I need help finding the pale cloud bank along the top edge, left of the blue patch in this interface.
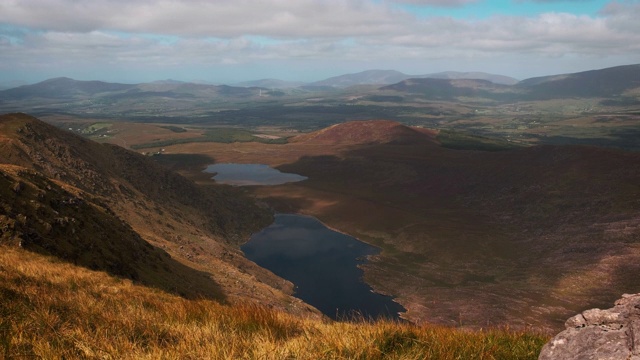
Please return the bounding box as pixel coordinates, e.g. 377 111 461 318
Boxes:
0 0 411 38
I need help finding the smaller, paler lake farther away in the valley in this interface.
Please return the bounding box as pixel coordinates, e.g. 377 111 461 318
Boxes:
204 164 307 186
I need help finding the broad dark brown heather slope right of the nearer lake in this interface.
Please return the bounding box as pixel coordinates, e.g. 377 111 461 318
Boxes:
274 131 640 328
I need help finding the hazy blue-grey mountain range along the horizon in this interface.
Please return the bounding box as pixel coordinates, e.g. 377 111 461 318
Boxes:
0 65 640 108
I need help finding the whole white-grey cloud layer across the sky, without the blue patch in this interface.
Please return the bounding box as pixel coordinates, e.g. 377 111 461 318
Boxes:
0 0 640 81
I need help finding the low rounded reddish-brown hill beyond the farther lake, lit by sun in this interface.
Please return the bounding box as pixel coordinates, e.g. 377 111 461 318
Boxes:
290 120 436 145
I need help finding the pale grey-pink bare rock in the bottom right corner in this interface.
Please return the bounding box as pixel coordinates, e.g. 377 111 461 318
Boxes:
538 294 640 360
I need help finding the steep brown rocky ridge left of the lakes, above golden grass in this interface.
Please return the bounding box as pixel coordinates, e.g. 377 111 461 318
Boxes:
0 114 304 308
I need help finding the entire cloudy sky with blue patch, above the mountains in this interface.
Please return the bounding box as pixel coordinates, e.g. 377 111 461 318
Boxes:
0 0 640 84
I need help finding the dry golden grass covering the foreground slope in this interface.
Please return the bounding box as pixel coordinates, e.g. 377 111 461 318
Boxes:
0 246 547 359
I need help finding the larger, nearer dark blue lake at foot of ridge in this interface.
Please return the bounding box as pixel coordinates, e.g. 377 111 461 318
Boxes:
242 214 406 319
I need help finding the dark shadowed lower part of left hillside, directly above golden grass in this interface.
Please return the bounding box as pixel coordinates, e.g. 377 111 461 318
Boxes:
0 171 225 302
